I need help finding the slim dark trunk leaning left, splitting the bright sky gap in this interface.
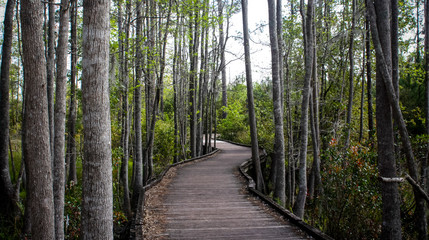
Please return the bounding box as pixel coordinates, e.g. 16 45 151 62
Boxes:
241 0 265 191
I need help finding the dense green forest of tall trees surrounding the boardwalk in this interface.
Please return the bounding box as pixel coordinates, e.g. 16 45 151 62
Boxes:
0 0 429 239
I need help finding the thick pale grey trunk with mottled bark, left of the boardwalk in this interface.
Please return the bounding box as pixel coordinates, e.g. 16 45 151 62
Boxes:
82 0 113 239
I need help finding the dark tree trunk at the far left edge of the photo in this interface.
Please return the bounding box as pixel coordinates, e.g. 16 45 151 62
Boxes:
0 0 17 219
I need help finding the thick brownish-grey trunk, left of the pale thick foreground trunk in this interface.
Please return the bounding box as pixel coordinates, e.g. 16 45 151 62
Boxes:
21 0 55 236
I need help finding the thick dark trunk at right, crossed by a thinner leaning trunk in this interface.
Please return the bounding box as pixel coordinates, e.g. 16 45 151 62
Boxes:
368 0 402 239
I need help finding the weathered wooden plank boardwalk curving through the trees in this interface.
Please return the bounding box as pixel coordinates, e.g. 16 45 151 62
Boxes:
164 142 308 240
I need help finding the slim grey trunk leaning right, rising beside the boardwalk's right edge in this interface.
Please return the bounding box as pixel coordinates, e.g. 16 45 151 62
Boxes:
293 0 314 218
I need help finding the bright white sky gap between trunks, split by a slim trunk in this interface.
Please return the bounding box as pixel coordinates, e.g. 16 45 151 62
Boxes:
225 0 271 82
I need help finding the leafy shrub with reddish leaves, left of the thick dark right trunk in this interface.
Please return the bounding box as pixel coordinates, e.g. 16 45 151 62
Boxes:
307 139 381 239
